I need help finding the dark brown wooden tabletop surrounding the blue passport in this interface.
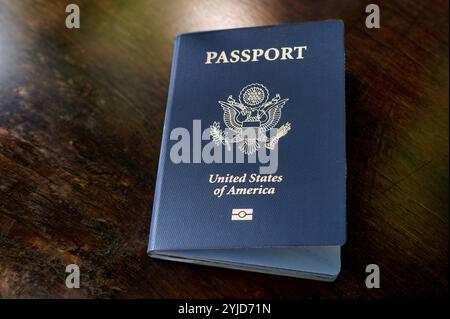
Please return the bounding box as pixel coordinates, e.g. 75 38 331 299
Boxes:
0 0 449 298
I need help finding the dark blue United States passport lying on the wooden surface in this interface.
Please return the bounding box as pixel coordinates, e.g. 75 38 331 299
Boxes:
148 20 346 281
